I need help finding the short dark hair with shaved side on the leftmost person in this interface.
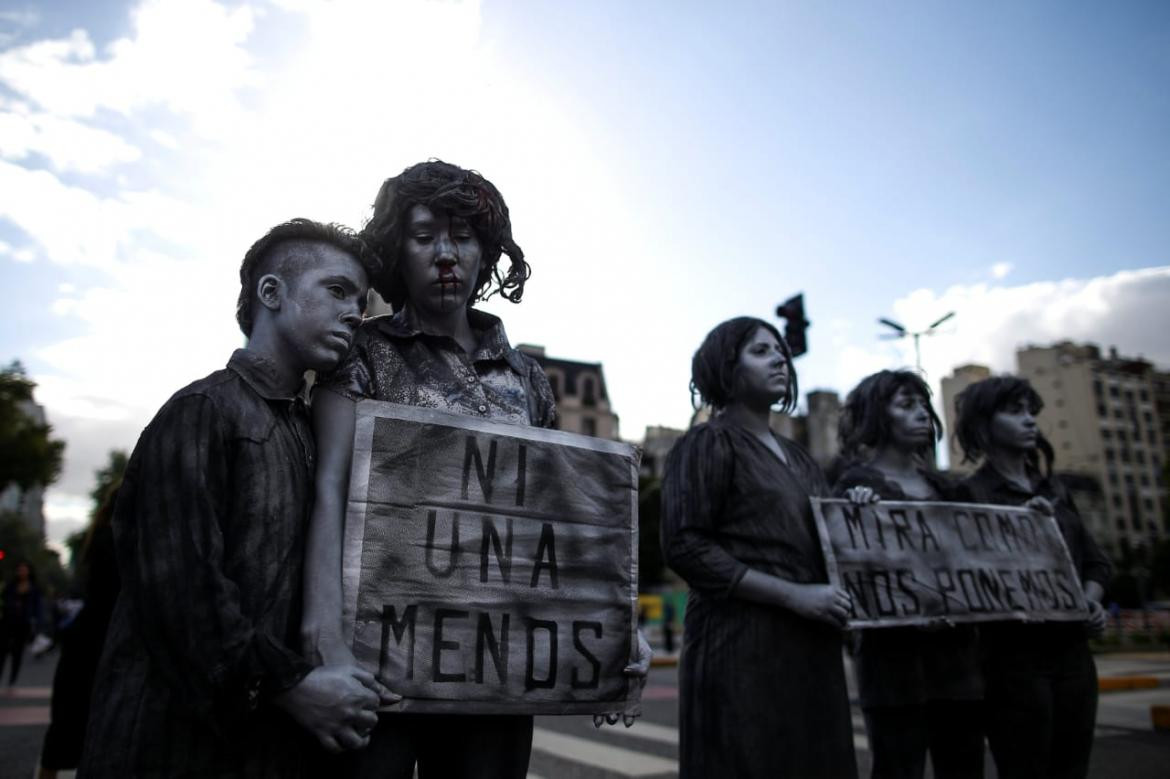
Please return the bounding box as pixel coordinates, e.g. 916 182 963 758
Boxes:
235 219 379 336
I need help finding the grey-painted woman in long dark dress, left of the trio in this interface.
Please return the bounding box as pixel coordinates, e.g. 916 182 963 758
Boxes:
662 317 856 779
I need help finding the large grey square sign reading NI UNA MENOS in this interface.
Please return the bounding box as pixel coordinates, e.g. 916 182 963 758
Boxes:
343 400 639 713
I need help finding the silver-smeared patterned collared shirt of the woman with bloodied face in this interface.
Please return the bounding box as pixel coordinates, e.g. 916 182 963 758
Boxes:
317 306 556 427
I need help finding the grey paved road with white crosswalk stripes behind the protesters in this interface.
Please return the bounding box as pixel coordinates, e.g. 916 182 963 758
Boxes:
0 653 1170 779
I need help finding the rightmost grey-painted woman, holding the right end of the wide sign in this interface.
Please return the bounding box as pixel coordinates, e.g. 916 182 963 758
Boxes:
955 377 1110 779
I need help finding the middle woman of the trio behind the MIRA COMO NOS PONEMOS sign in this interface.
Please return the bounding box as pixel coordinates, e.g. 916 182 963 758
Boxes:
834 371 983 779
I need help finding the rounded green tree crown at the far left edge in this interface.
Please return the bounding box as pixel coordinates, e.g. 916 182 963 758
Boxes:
0 363 66 489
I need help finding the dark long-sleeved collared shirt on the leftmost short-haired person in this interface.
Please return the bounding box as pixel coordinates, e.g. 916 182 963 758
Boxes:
82 350 315 777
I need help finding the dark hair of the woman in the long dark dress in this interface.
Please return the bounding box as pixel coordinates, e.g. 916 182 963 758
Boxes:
690 317 799 414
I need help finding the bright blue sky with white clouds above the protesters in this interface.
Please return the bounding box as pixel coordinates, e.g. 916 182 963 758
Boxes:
0 0 1170 538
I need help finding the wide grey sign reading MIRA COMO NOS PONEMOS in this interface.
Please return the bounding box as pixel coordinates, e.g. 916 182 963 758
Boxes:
812 498 1088 627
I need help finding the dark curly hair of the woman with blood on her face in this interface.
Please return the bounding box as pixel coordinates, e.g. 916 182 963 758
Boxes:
362 159 532 310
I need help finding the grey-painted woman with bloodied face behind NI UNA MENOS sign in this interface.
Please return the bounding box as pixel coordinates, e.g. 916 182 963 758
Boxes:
304 160 556 779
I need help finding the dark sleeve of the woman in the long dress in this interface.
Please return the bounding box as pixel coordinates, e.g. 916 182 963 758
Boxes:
661 426 748 595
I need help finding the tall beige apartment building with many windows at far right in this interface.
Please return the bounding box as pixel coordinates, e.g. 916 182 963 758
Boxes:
1016 342 1170 551
